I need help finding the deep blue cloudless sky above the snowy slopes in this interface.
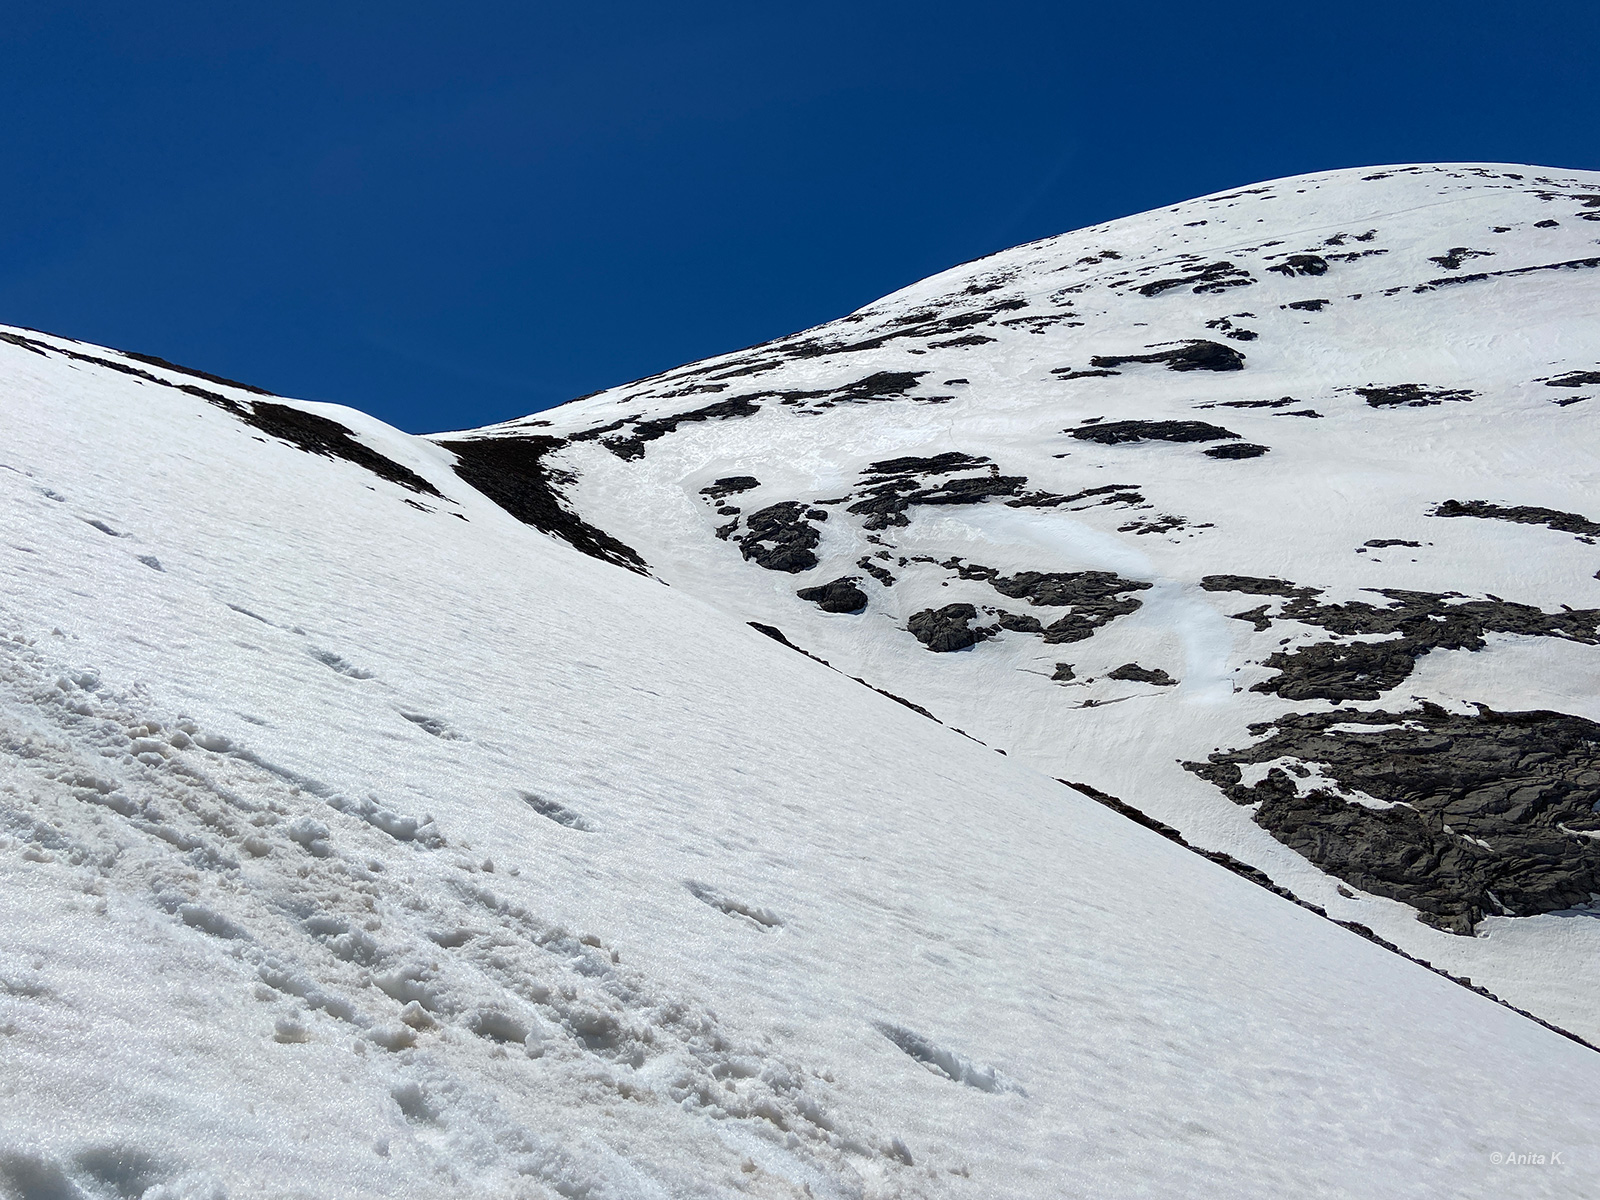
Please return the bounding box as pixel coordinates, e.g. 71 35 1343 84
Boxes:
0 0 1600 430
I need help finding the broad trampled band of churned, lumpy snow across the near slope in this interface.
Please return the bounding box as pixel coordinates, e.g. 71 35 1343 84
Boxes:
0 635 1010 1195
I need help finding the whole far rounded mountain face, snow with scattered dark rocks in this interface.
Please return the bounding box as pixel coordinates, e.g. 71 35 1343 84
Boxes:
454 165 1600 1038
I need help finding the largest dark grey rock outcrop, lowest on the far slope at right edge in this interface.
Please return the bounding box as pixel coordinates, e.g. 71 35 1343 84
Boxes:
1186 704 1600 933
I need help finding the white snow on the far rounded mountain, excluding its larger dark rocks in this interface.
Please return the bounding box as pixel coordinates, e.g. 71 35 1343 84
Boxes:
467 165 1600 1040
